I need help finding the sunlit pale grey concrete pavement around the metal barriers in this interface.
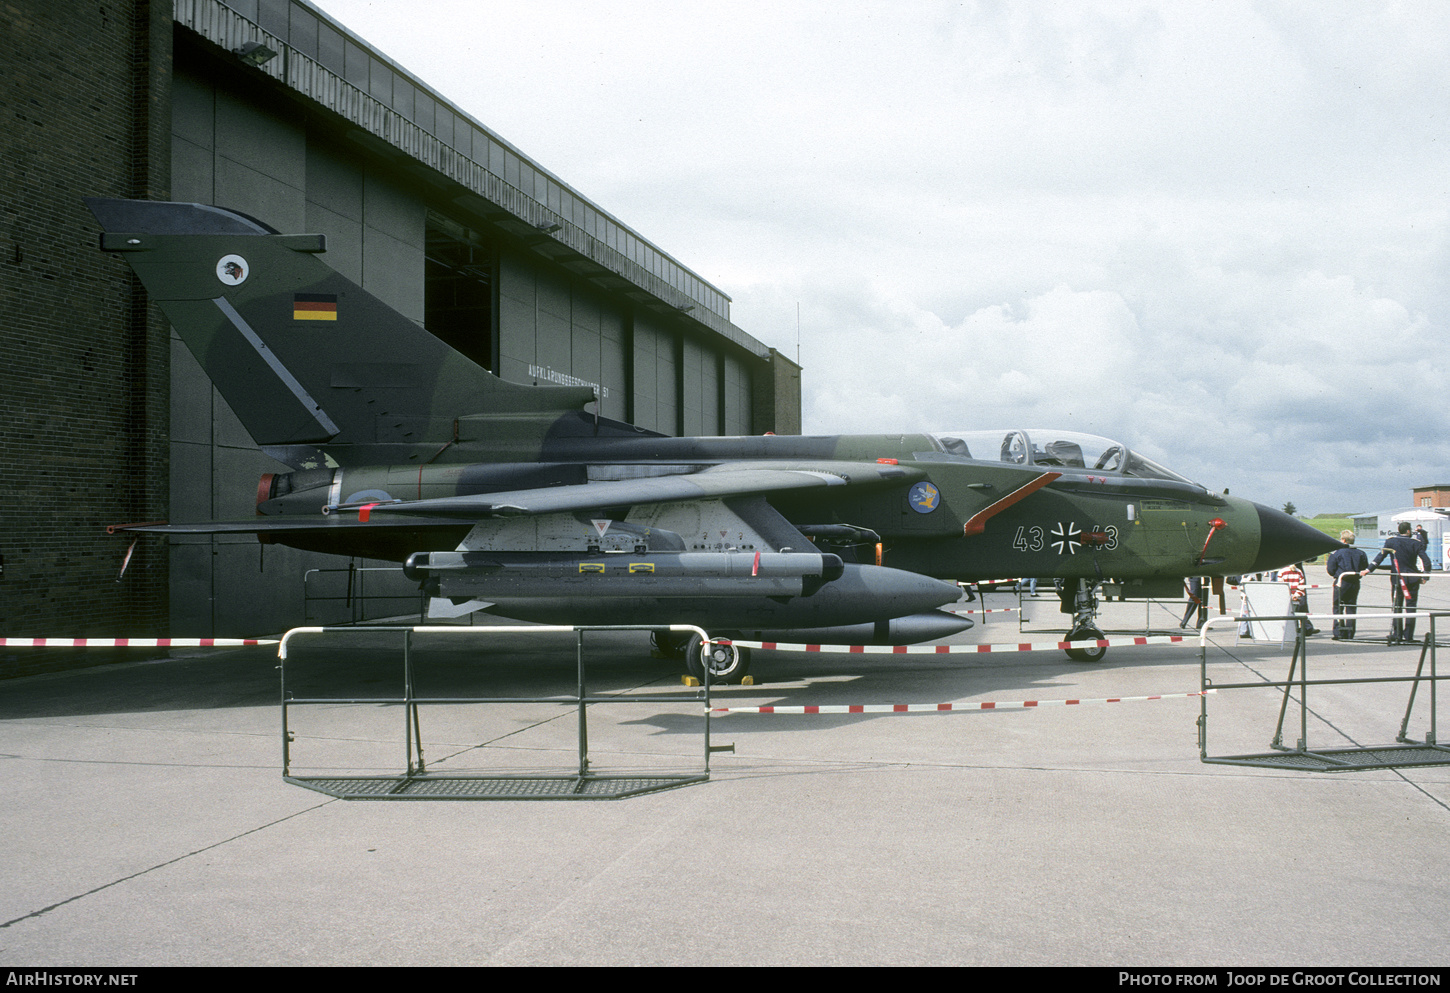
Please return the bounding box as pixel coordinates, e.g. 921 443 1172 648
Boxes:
0 586 1450 967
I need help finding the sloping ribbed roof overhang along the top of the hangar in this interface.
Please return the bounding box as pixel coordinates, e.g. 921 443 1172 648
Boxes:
173 0 771 360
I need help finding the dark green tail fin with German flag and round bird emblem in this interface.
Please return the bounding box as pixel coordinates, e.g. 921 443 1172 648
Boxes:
86 199 595 463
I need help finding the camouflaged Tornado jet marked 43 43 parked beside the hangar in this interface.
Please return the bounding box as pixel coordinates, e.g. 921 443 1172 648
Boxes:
86 199 1340 681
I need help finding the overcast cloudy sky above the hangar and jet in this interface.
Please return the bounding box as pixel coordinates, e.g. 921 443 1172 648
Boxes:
315 0 1450 515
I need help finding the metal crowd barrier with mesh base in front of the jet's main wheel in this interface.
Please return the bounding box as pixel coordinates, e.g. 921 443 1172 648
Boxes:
277 625 734 800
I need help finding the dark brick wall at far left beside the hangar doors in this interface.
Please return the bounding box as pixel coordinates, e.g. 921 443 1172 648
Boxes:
0 0 171 676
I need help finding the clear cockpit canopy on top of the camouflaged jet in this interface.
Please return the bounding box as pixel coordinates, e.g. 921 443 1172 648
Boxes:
932 429 1193 484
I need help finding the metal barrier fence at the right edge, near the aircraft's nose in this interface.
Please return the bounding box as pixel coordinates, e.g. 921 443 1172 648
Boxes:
1198 612 1450 773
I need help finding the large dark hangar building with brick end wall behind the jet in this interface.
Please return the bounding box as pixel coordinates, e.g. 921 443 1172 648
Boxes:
0 0 800 674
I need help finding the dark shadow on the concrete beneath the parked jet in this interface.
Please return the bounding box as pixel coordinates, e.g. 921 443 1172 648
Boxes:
0 635 1218 724
